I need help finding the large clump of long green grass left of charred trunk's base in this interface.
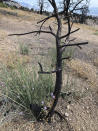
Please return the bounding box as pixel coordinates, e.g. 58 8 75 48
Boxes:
0 65 54 114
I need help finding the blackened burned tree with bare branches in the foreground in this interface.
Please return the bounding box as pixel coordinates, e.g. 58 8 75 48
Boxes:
10 0 88 121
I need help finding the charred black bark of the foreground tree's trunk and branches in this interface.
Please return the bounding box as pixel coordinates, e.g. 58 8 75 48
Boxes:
9 0 88 121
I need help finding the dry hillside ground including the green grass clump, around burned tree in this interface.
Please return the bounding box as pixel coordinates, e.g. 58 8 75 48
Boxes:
0 1 98 131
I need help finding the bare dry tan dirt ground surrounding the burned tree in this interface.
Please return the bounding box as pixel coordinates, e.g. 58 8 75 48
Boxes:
0 8 98 131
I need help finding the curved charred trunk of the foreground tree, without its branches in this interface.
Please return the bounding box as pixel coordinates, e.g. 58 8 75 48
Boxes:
47 16 62 118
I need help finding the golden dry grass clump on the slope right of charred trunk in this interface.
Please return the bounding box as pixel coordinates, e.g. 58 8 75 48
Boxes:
67 59 97 86
